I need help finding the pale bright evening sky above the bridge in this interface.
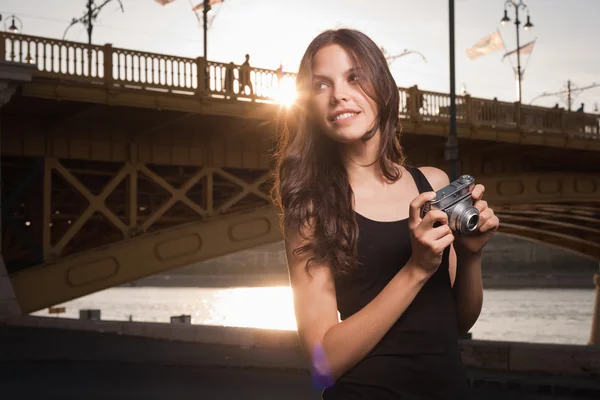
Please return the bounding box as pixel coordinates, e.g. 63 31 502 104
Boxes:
0 0 600 113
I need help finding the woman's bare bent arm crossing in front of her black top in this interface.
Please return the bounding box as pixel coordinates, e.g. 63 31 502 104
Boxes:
285 194 453 386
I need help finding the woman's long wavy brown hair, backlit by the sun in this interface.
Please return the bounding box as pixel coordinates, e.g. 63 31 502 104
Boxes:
272 29 404 275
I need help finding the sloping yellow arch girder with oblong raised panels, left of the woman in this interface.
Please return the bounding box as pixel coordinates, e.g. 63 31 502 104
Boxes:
11 206 282 313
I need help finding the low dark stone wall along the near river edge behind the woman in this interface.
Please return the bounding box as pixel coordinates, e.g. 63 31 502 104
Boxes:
0 316 600 382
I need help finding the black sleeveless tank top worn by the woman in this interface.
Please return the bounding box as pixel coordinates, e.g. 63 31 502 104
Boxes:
322 166 468 400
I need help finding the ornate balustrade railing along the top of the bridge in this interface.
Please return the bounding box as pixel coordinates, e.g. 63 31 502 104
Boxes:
0 32 600 140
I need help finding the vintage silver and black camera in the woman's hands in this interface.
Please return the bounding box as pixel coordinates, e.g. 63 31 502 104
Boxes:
421 175 479 235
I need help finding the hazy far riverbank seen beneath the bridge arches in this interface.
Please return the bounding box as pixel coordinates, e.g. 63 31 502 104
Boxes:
124 234 598 289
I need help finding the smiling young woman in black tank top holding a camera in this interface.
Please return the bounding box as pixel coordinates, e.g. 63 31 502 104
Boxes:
274 29 498 400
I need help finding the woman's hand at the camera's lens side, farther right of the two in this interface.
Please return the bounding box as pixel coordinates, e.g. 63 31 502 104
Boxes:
454 184 500 253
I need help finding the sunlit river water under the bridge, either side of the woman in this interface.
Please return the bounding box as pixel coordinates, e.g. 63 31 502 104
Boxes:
33 286 594 344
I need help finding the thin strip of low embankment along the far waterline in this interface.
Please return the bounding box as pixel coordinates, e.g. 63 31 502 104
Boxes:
127 273 594 289
